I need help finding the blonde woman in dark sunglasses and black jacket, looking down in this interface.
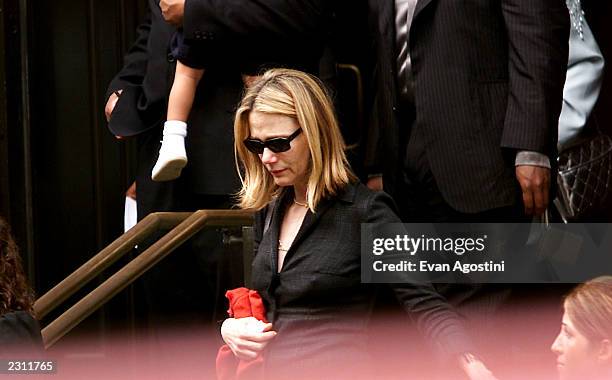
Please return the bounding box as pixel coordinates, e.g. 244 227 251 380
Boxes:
221 69 489 378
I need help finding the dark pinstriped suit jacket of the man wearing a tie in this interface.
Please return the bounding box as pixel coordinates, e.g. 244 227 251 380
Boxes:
369 0 569 212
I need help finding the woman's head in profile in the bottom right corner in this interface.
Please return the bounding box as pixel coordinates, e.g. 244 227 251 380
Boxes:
551 276 612 380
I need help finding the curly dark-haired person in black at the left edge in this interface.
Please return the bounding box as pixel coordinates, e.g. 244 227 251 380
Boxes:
0 217 43 359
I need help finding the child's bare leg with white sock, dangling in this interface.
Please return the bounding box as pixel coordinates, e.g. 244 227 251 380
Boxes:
151 62 204 181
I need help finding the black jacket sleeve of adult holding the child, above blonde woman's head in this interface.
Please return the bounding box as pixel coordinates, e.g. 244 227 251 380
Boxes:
181 0 336 75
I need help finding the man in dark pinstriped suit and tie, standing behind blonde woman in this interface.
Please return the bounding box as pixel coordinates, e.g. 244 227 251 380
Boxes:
369 0 569 222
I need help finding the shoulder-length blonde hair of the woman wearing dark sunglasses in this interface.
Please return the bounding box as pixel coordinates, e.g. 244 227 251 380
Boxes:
234 69 356 212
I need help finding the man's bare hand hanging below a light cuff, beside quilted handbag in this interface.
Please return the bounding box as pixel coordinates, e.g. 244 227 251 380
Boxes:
516 165 550 216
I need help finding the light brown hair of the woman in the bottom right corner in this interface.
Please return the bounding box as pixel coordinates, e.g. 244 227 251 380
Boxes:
564 276 612 342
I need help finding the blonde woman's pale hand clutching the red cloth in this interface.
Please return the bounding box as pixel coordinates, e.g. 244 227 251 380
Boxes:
221 317 276 360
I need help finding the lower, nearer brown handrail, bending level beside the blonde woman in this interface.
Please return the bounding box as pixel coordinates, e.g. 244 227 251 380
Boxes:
42 210 253 348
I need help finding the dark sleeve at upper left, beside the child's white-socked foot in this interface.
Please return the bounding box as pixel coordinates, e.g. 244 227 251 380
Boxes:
105 7 151 99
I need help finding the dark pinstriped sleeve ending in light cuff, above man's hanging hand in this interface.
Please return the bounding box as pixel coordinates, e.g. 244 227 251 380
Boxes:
501 0 570 158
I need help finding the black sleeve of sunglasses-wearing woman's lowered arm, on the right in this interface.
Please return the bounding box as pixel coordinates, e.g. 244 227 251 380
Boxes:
366 192 475 360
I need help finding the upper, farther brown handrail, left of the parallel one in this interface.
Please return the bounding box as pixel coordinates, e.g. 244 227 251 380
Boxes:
34 212 191 320
